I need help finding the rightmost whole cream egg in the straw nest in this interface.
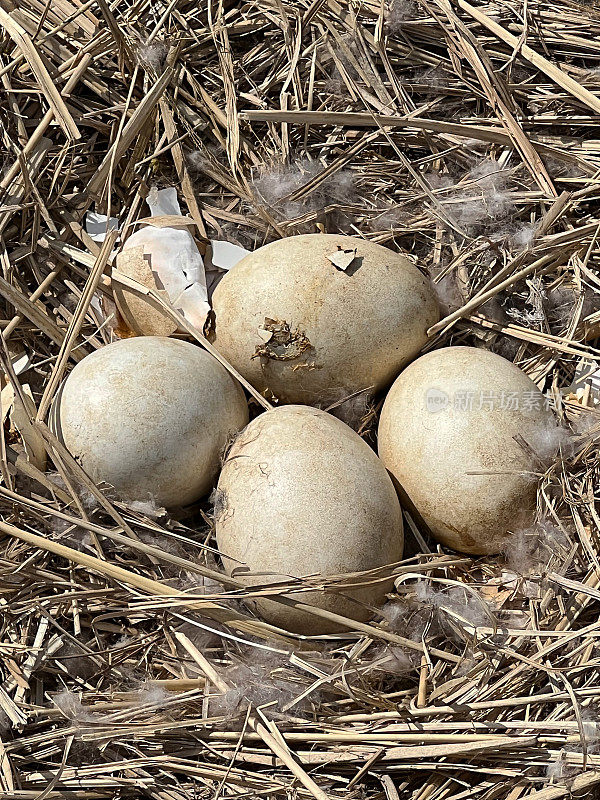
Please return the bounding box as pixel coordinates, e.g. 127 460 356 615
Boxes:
379 347 556 554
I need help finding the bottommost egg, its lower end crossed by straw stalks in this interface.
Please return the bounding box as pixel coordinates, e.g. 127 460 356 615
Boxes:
215 405 403 634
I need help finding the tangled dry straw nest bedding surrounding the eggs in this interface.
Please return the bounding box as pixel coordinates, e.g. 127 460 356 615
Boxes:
0 0 600 800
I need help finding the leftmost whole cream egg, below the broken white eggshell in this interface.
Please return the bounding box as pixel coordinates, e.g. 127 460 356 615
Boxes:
51 336 248 508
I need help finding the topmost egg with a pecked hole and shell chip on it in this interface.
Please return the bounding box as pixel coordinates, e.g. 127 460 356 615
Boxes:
210 234 439 406
